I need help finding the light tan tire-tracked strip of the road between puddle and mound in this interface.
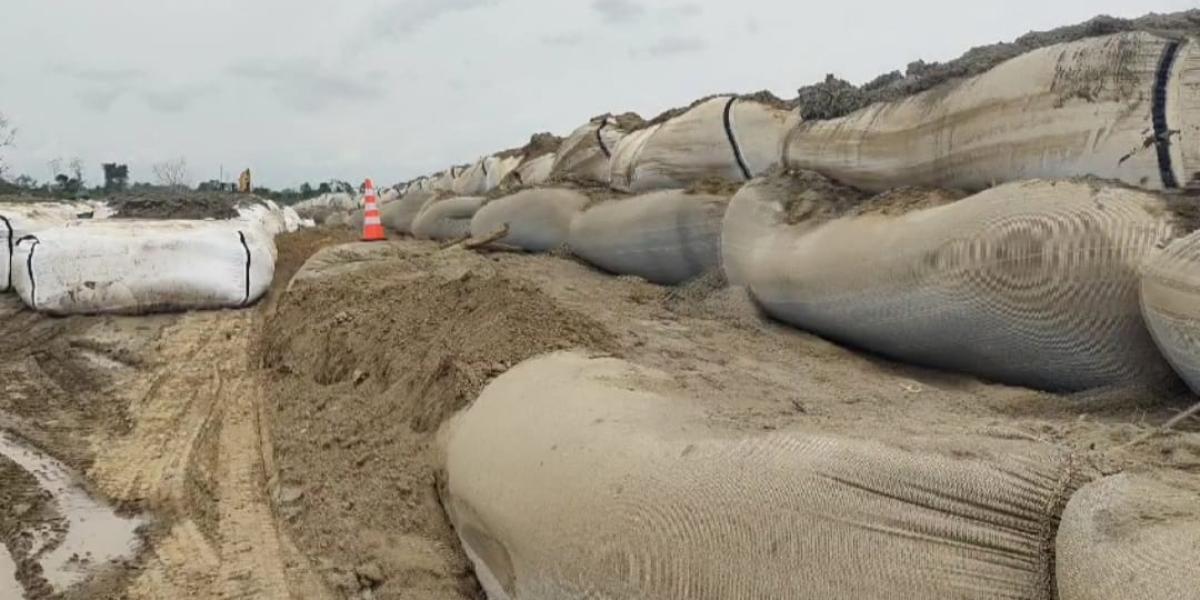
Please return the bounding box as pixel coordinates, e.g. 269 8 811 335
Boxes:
90 311 328 599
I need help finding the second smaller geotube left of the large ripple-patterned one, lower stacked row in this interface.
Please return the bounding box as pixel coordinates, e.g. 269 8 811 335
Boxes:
470 187 589 252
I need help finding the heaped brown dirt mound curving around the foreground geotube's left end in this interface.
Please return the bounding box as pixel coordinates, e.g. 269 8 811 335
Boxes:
263 245 614 599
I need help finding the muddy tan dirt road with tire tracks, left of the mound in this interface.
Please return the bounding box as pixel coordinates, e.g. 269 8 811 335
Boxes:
0 229 344 599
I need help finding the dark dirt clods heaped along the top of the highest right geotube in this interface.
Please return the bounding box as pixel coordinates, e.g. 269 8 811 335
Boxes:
794 10 1200 120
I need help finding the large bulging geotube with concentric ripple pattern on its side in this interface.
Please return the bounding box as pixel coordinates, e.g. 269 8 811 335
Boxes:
722 175 1188 390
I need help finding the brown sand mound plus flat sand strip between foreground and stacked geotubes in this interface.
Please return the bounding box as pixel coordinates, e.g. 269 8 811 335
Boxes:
264 236 1200 598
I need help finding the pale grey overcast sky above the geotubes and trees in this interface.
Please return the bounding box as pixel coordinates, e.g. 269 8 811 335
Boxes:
0 0 1198 187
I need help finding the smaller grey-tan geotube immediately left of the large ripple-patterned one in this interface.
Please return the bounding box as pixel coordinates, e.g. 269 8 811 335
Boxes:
568 190 728 284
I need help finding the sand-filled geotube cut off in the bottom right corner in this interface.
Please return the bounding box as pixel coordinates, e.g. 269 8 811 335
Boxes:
1057 472 1200 600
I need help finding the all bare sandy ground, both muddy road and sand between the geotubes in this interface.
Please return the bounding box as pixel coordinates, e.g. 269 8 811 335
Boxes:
0 230 1200 599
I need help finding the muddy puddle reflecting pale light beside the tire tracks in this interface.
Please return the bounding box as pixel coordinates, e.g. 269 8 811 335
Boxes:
0 431 144 598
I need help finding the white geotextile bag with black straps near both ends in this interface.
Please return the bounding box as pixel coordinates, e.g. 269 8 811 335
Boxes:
12 221 276 314
